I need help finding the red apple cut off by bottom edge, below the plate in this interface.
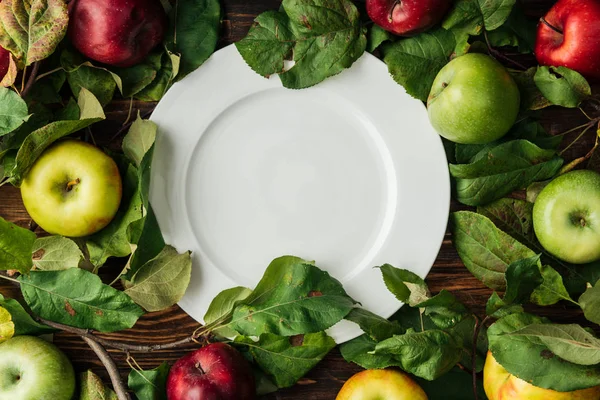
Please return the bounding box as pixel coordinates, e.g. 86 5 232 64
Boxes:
167 343 256 400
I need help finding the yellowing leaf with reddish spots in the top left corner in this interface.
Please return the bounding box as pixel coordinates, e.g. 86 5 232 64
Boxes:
0 0 69 65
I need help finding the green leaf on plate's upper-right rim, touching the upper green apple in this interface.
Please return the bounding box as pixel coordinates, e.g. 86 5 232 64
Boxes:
382 28 456 101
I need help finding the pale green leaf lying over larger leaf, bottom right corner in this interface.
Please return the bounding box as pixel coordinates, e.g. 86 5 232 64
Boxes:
508 324 600 365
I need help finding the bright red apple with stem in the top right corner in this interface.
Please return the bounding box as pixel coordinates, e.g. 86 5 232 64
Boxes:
535 0 600 79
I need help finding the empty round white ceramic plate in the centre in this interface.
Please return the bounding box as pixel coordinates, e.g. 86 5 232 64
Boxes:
150 45 450 343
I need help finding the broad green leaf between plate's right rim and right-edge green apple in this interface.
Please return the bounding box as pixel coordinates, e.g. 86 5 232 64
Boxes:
450 211 536 290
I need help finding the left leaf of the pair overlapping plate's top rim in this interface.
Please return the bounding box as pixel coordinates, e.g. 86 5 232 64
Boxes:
235 11 295 76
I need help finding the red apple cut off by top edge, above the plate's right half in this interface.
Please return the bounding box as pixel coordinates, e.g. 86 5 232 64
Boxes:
367 0 452 36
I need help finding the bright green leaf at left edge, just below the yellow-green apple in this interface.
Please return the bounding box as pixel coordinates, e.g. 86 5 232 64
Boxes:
0 217 36 274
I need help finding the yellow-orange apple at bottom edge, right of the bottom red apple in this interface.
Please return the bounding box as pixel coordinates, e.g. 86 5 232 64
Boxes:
336 369 427 400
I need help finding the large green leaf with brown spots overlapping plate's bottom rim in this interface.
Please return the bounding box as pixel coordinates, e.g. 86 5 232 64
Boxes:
227 256 354 336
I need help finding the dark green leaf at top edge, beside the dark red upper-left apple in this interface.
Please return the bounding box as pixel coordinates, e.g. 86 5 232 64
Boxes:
165 0 221 80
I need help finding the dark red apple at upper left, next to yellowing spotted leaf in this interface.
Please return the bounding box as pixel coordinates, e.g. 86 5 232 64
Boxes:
69 0 167 67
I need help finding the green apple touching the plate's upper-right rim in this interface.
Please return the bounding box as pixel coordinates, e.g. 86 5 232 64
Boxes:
427 53 520 144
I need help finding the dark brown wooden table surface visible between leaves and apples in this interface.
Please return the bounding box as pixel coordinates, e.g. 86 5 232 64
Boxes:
0 0 600 400
